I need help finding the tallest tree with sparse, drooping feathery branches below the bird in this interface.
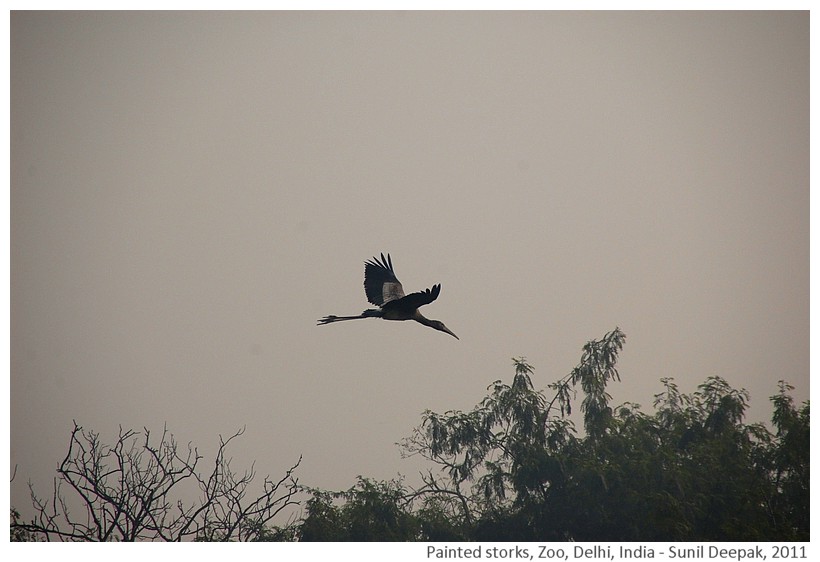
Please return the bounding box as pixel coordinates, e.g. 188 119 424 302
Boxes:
403 328 626 540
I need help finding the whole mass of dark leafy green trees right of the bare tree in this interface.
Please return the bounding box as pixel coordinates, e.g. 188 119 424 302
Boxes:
302 329 809 541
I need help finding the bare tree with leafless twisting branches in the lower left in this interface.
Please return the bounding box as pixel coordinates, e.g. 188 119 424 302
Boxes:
11 422 302 541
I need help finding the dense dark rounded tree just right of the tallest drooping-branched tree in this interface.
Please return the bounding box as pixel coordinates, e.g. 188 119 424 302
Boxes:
548 377 776 540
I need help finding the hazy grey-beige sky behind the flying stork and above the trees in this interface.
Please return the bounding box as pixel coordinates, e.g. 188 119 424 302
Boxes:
10 8 809 511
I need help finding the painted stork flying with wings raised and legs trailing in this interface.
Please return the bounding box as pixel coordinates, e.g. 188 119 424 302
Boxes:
319 254 458 339
